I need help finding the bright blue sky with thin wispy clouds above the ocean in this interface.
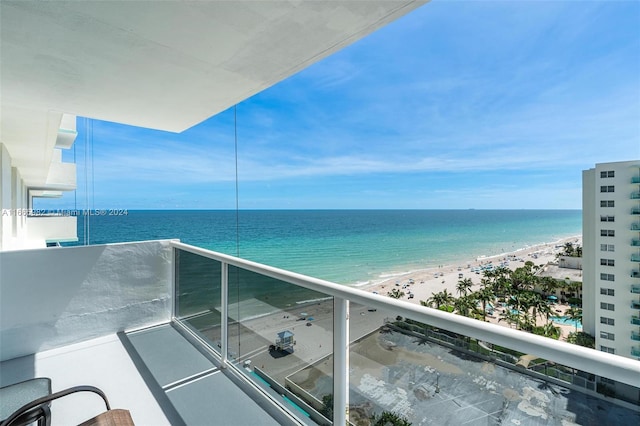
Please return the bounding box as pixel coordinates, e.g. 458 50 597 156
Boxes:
52 0 640 209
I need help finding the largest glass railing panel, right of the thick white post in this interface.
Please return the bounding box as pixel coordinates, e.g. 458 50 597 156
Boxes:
349 307 640 425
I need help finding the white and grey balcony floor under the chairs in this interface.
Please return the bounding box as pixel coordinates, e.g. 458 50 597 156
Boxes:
0 324 298 425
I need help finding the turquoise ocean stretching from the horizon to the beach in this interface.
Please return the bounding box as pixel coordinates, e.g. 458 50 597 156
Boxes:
70 210 582 285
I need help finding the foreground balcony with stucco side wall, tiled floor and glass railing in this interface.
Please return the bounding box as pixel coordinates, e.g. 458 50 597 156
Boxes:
0 241 640 425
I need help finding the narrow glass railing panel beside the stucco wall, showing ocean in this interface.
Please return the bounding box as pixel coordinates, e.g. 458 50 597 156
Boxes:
176 249 222 350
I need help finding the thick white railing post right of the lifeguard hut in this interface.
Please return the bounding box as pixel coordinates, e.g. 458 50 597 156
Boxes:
333 297 349 426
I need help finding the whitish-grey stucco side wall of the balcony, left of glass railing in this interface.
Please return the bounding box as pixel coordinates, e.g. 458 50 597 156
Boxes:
0 241 172 361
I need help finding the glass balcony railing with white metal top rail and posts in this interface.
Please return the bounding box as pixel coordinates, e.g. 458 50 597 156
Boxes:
172 242 640 425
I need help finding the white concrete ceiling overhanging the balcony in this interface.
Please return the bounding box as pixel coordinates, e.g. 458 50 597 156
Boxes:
0 0 426 186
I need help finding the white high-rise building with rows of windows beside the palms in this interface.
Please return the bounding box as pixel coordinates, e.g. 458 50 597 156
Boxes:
582 160 640 359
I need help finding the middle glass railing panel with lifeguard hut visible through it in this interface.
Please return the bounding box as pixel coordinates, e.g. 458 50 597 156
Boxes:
228 266 333 423
